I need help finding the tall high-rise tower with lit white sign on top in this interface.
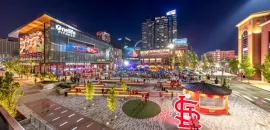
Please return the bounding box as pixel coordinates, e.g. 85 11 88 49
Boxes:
142 10 177 50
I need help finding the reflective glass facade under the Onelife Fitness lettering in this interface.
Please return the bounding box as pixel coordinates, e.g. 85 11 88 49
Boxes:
45 21 112 63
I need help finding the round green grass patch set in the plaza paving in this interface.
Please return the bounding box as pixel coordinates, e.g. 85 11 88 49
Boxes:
122 99 161 119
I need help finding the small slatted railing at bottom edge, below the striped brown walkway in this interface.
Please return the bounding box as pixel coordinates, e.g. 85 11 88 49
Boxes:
30 115 54 130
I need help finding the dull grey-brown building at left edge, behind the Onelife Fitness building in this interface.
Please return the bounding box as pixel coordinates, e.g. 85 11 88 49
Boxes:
0 38 20 60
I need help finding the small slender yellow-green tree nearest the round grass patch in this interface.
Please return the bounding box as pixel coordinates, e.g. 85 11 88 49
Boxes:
107 86 118 112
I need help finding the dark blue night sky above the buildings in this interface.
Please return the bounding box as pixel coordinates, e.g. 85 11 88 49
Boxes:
0 0 270 55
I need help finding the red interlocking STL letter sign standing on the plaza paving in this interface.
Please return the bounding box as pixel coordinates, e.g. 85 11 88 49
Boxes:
174 95 202 129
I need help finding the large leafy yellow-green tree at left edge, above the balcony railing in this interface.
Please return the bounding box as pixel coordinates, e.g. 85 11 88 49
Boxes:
0 72 23 117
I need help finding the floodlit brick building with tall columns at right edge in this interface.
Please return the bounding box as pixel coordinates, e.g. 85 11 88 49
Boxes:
236 10 270 80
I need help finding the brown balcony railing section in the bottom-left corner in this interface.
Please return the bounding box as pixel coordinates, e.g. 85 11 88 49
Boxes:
0 105 24 130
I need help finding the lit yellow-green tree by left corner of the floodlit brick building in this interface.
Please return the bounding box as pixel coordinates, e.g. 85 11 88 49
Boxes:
241 56 255 83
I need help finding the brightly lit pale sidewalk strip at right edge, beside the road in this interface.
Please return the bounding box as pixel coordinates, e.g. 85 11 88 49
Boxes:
234 79 270 91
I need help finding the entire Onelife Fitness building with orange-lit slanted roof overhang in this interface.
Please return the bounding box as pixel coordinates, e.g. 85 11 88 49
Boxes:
9 14 117 75
